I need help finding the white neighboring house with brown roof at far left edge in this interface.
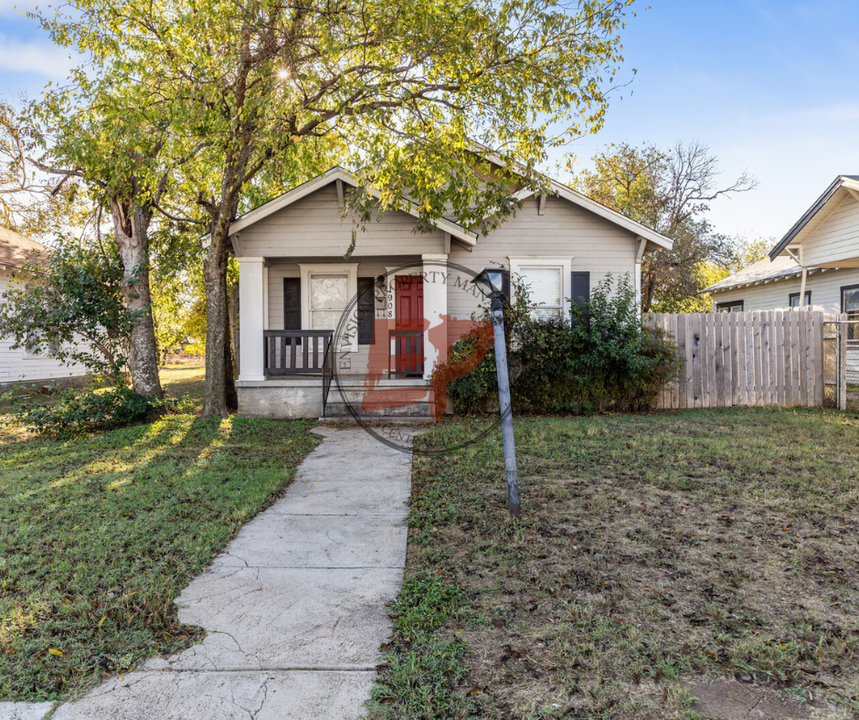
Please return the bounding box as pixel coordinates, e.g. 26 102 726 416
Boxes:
0 227 87 388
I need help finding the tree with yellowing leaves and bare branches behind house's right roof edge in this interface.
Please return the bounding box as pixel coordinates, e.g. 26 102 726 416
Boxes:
575 142 756 312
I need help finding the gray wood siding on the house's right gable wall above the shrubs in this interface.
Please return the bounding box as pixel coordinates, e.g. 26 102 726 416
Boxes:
447 197 637 342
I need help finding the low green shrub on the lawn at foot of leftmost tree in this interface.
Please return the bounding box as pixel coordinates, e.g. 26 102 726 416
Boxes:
7 387 187 435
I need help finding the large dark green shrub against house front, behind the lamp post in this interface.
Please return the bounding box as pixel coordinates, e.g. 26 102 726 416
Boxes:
448 276 679 414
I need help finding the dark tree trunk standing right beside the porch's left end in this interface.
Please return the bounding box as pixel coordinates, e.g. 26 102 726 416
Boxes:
198 221 236 417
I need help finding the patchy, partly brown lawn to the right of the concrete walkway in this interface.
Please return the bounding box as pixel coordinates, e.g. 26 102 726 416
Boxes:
371 408 859 720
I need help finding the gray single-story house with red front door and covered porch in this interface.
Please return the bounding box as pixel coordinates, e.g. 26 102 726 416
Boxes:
230 168 671 417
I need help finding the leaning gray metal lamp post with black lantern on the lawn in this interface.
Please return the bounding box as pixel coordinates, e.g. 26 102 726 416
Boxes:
472 268 520 518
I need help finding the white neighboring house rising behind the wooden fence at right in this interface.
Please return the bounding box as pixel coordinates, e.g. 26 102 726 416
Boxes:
703 175 859 320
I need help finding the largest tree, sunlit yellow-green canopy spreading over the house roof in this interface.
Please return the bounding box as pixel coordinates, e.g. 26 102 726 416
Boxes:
40 0 633 416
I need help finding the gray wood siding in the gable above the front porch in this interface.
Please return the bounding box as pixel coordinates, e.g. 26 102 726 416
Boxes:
239 184 444 259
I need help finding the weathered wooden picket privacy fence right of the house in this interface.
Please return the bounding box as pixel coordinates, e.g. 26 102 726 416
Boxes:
644 310 840 408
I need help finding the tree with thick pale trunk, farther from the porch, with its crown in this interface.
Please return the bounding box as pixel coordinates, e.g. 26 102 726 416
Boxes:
26 76 195 398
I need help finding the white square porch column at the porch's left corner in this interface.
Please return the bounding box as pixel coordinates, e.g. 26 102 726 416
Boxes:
237 257 266 381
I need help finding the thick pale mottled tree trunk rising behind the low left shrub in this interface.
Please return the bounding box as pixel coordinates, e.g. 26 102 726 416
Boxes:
110 198 164 399
